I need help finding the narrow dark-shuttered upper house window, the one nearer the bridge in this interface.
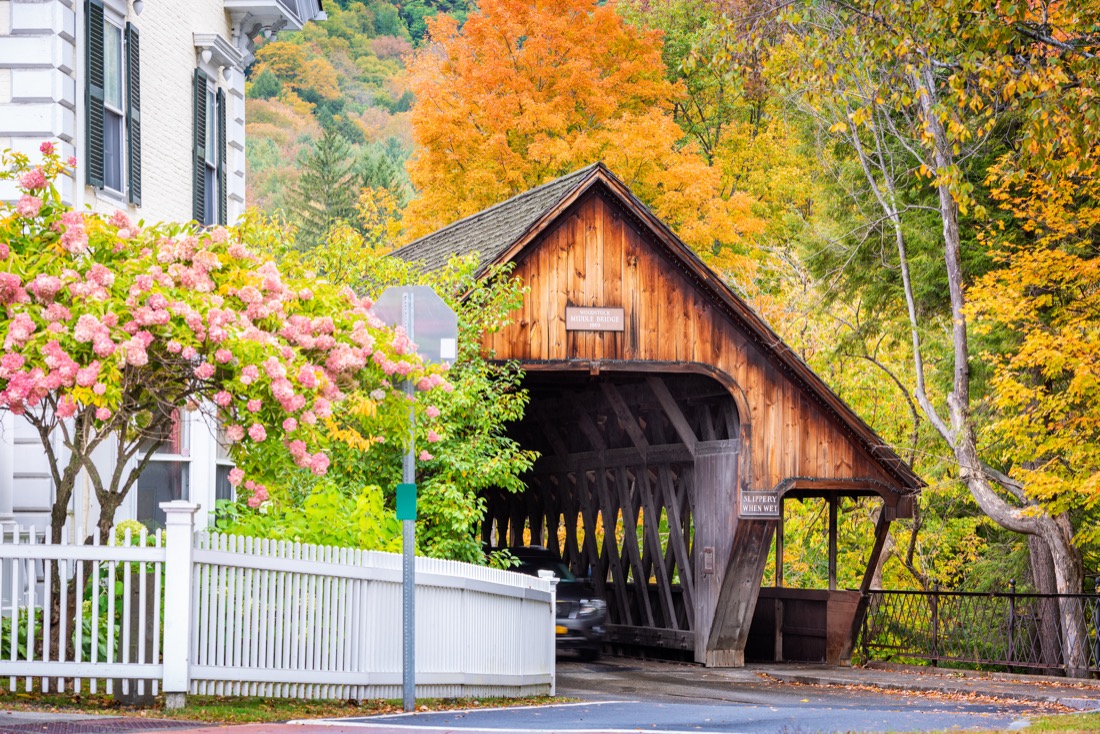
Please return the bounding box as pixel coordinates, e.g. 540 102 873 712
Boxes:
194 69 229 226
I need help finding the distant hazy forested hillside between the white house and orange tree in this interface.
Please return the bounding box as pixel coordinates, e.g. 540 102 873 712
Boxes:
248 0 468 241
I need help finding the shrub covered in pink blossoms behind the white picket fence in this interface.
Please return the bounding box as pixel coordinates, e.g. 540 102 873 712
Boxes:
0 144 447 539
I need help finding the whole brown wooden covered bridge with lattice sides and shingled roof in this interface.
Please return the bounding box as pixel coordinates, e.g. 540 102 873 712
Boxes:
395 164 921 666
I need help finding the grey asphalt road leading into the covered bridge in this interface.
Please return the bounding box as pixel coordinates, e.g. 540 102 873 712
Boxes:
312 658 1036 734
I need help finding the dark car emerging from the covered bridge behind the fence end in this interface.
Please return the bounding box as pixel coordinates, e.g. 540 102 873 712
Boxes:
508 546 607 660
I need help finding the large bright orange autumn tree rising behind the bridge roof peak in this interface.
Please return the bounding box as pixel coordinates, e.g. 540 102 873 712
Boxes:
405 0 763 284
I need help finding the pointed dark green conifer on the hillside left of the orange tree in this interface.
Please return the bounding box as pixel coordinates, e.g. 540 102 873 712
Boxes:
292 129 360 249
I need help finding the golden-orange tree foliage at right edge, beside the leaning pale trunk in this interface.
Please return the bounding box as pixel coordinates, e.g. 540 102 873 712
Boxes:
969 165 1100 546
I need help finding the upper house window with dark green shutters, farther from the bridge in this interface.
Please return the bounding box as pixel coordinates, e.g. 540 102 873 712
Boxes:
85 0 141 206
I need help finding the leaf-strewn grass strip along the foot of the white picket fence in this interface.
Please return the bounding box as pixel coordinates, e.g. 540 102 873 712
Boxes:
0 689 571 724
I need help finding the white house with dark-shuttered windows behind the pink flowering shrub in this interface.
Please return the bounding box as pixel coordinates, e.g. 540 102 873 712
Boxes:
0 0 325 541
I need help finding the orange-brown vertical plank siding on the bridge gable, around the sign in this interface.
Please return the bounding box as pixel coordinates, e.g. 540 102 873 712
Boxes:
484 188 899 497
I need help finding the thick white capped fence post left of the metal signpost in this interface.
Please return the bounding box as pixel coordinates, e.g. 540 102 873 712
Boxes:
161 500 199 709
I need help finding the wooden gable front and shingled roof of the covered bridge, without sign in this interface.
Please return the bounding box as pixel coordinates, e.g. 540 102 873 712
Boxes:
394 163 923 508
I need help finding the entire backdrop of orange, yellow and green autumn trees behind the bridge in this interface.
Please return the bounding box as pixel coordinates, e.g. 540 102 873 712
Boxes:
249 0 1100 611
